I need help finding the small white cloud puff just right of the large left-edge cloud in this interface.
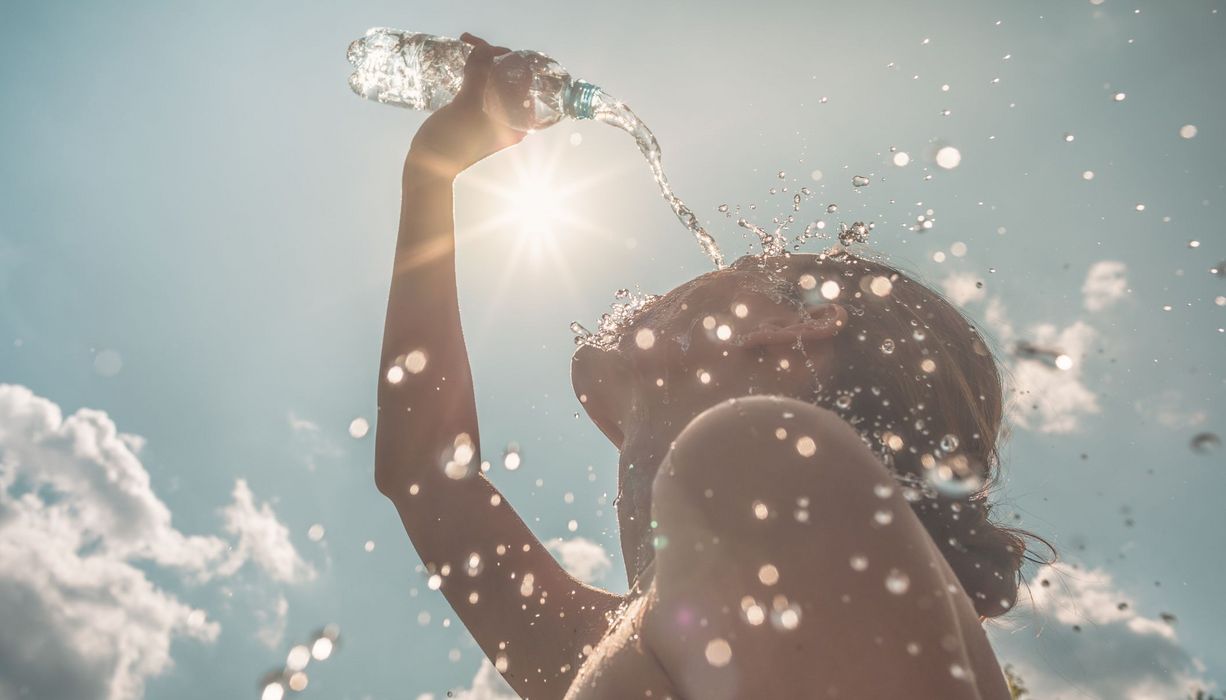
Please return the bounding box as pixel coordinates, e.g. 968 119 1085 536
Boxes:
221 479 315 584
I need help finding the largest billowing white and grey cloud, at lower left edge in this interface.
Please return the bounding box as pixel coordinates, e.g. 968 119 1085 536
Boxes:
0 385 311 700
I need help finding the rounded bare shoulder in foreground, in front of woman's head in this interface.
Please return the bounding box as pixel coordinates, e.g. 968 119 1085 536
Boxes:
645 397 1008 699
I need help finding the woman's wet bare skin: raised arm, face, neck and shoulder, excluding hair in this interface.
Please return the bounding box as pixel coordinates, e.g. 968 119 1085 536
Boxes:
375 31 1008 700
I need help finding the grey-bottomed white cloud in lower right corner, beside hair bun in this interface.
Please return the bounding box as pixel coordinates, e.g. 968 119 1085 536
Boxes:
989 565 1211 700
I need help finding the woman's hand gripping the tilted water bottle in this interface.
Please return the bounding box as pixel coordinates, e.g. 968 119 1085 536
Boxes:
405 32 525 179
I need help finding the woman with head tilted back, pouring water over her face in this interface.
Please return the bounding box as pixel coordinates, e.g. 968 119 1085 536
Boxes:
375 34 1044 700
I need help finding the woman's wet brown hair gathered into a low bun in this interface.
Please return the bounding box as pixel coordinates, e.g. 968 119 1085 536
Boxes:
632 251 1054 617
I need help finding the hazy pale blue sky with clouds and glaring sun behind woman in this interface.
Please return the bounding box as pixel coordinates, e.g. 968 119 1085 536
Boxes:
0 0 1226 700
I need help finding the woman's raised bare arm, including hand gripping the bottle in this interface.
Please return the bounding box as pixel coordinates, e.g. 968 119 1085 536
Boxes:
375 34 622 700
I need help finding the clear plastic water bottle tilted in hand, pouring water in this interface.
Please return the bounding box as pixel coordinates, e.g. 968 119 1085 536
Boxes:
348 27 600 131
